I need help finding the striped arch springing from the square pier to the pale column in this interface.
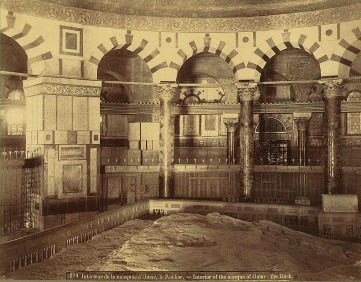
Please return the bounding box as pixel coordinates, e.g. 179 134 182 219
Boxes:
89 32 168 79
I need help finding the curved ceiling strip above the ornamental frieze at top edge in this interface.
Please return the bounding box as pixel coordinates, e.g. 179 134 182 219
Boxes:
41 0 361 18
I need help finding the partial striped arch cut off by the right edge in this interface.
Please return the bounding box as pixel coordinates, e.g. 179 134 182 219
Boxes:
331 27 361 78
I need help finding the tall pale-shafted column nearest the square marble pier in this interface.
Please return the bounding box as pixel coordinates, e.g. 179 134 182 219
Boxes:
157 84 176 198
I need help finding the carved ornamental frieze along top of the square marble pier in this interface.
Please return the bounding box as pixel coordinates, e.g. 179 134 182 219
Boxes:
25 83 101 97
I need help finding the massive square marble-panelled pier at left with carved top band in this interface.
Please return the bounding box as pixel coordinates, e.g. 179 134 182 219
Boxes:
24 77 102 229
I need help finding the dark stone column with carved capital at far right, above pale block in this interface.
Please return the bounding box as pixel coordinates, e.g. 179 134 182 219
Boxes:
320 79 343 194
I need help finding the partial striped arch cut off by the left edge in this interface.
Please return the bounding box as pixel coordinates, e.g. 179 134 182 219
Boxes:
0 12 53 75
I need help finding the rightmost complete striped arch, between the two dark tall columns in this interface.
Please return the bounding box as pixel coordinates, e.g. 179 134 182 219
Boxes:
247 32 329 81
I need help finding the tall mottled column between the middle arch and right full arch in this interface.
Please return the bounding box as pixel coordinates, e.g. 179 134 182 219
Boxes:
236 83 258 201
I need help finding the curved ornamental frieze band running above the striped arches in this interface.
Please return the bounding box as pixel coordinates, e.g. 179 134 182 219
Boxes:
2 0 361 32
